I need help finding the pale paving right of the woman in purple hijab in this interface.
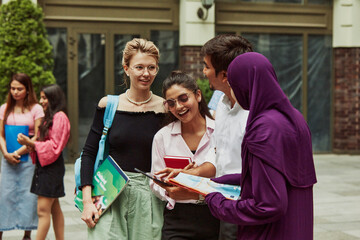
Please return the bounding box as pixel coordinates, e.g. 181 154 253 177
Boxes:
314 155 360 240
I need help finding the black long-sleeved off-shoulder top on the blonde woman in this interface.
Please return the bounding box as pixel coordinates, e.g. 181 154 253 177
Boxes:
81 107 165 186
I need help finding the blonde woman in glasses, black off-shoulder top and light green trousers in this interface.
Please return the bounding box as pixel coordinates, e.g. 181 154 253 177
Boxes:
80 38 165 240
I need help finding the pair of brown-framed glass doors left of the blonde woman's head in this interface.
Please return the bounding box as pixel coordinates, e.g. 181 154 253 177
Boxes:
68 29 140 158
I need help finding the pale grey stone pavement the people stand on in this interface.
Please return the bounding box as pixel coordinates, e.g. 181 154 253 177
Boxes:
0 154 360 240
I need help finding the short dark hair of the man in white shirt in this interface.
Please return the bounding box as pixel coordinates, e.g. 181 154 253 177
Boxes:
201 34 253 75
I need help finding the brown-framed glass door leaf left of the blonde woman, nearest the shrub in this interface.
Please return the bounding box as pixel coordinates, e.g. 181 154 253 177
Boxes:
68 29 108 156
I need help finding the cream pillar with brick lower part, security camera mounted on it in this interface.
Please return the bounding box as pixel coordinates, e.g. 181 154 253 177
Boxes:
179 0 215 79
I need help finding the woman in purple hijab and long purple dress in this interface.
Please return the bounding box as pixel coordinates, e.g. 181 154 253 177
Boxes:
205 52 316 240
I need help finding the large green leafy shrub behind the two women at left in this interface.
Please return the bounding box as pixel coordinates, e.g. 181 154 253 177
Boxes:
0 0 55 103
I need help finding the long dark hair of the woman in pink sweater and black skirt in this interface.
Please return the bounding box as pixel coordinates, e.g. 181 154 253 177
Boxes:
39 84 67 141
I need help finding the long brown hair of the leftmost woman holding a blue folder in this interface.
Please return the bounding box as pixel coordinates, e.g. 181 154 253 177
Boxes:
4 73 38 123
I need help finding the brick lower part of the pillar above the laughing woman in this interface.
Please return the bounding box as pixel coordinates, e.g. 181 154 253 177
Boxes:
180 46 204 79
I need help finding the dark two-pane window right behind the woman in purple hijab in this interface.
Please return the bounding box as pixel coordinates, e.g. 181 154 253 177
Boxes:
242 33 332 152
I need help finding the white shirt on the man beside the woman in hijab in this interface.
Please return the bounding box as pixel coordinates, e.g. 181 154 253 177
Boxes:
206 94 249 177
